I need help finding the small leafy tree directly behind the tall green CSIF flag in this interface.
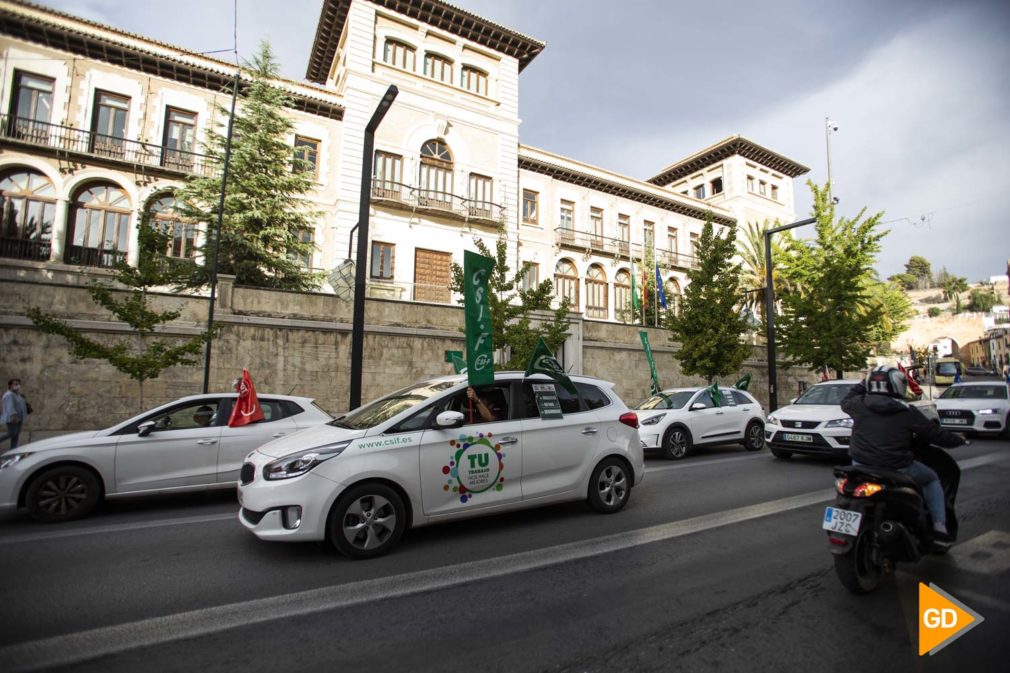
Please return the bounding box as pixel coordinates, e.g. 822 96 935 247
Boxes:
451 236 570 370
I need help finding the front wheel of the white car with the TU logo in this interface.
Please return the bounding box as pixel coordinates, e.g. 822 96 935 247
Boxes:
326 482 407 560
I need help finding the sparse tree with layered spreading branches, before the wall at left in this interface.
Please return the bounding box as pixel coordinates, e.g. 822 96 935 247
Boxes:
27 219 210 409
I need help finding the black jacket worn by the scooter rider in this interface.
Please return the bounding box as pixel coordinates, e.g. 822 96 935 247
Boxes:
841 383 965 470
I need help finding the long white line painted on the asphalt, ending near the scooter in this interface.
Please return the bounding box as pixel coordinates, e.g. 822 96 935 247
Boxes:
0 489 834 673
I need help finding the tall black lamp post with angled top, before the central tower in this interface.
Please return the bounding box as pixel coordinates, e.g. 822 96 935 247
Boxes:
347 84 400 409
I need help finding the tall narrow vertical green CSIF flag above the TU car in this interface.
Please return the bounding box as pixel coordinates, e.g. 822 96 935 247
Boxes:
463 250 495 386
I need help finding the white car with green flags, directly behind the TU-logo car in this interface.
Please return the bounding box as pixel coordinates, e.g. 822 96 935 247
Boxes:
637 388 765 460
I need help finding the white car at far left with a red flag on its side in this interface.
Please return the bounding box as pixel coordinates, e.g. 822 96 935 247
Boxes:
0 393 332 521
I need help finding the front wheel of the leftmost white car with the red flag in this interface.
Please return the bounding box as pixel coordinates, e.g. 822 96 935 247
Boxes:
24 465 102 523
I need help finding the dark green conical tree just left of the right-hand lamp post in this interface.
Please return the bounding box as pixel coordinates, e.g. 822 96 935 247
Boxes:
665 213 750 383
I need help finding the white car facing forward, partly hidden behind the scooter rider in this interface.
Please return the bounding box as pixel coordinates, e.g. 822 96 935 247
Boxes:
765 380 939 461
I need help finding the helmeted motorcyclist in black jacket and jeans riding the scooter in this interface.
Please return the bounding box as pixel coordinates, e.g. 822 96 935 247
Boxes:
841 366 965 547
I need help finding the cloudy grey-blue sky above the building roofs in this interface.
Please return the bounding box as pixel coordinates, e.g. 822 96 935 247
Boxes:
42 0 1010 282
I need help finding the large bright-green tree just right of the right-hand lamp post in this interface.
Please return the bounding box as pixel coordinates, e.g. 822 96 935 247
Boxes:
778 181 887 378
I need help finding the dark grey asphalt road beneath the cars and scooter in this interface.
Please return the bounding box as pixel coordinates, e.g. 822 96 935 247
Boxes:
0 440 1010 673
